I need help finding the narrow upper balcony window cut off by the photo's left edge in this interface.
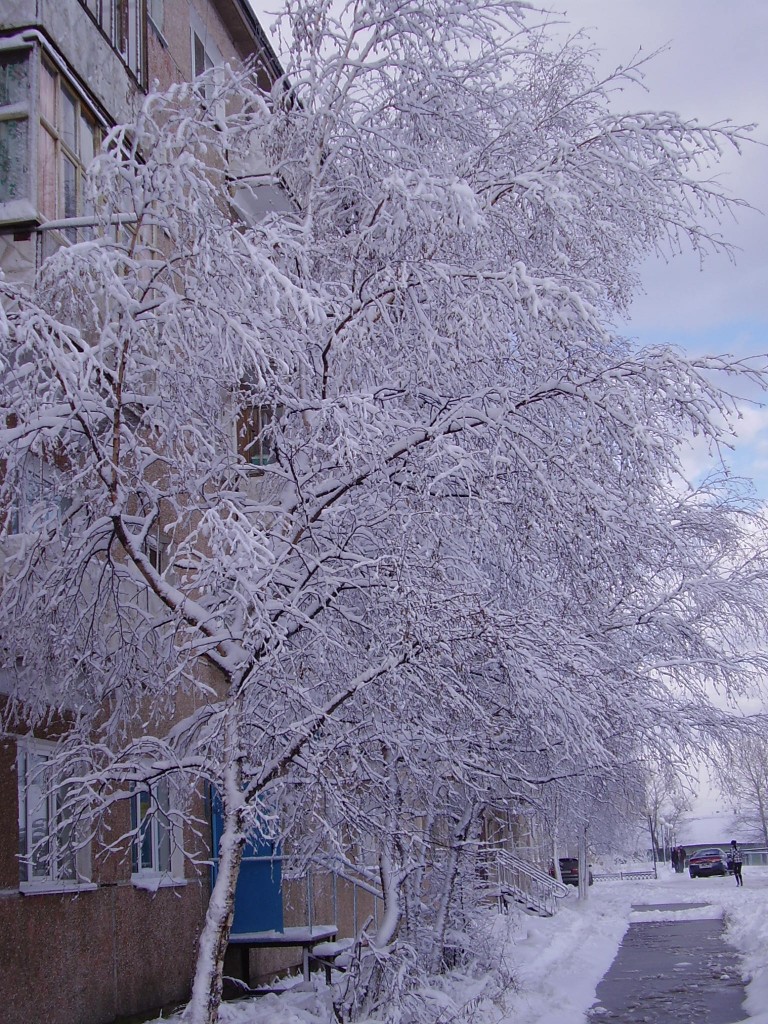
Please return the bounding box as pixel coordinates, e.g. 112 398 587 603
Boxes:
0 49 31 204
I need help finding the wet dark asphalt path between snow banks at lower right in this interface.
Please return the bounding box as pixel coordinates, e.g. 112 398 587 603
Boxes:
589 903 744 1024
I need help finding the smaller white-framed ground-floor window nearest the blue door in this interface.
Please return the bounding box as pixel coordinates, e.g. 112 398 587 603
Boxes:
130 777 186 891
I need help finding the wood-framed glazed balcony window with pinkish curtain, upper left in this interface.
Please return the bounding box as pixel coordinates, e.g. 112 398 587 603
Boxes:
38 60 101 242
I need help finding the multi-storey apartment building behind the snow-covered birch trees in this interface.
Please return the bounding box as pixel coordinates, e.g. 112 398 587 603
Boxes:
0 0 373 1024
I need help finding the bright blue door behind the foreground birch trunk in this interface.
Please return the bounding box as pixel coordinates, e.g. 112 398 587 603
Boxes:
211 791 283 935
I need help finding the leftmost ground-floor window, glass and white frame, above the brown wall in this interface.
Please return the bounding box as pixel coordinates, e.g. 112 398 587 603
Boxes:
16 738 90 892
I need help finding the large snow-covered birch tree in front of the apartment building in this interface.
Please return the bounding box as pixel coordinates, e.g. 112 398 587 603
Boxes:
0 0 768 1024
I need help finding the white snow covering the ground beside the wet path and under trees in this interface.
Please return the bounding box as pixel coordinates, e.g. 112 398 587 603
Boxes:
153 867 768 1024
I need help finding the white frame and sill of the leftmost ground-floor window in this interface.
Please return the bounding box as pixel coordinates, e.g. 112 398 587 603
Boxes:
16 736 96 895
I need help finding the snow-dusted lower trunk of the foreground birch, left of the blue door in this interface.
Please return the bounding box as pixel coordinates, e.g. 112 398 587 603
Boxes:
183 765 246 1024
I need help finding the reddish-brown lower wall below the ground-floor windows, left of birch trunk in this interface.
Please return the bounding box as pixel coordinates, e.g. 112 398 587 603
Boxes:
0 881 207 1024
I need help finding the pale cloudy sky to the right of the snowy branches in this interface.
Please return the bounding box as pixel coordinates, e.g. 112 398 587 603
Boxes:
252 0 768 501
